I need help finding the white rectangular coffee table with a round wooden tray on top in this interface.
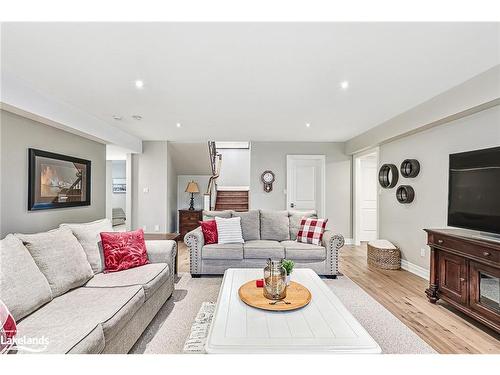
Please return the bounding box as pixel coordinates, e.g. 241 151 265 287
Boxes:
206 268 381 353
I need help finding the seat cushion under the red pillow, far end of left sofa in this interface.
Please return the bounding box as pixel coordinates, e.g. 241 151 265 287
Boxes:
85 263 170 301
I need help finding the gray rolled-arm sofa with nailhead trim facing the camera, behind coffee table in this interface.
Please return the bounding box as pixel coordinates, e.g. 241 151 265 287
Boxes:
184 210 344 277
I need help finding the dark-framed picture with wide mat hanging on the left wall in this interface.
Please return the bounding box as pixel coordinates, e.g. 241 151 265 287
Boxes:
28 148 91 211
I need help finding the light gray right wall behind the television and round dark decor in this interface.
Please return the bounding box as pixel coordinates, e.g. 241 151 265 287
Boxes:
379 106 500 269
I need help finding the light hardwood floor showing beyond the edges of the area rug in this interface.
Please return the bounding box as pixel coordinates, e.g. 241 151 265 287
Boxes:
178 242 500 354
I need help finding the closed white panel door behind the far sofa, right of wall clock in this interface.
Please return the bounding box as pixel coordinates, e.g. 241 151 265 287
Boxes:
286 155 325 217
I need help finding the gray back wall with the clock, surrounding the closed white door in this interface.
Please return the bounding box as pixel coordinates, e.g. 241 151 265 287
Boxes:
250 142 352 238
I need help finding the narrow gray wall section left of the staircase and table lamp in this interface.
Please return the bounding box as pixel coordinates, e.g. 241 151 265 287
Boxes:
128 141 169 232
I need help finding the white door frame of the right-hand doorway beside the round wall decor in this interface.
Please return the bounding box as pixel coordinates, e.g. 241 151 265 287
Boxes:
352 147 380 246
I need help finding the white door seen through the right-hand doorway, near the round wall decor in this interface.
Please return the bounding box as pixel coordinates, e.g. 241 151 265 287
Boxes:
357 154 378 241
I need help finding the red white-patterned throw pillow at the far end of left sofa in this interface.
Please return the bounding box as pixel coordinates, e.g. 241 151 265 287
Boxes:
101 229 148 272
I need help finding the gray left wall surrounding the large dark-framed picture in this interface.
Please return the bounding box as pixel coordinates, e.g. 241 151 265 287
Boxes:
0 110 106 238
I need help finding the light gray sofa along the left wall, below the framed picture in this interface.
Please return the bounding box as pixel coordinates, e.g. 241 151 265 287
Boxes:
0 220 177 353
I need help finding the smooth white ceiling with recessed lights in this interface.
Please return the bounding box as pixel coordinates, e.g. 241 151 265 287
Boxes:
1 23 500 141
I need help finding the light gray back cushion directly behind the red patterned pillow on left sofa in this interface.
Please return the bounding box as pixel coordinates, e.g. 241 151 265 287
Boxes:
60 219 113 273
